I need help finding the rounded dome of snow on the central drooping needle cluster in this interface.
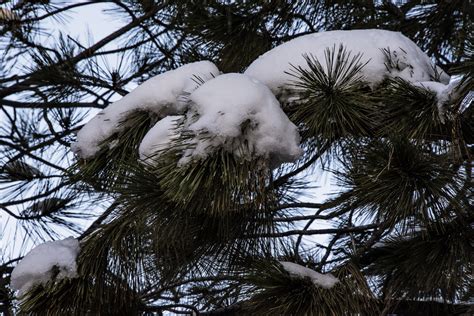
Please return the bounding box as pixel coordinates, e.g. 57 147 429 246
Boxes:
167 73 301 165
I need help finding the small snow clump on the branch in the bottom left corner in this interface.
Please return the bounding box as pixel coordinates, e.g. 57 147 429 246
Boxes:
10 237 79 296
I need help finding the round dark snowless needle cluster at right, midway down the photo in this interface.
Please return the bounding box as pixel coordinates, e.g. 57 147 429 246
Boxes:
336 138 465 225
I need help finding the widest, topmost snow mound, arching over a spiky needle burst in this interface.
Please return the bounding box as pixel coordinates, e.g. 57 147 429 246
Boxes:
245 29 449 95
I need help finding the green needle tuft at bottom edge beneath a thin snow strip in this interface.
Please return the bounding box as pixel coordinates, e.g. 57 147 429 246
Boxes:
243 259 377 316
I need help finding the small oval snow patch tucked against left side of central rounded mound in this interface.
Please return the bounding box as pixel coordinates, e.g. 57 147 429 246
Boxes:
138 115 184 161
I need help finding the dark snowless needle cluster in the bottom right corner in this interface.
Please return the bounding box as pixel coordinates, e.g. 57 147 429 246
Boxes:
365 216 473 302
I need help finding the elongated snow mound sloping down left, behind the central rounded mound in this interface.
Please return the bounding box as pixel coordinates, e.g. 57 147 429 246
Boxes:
71 61 219 159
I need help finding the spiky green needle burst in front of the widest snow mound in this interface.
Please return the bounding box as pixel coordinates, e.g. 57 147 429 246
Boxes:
288 45 377 141
